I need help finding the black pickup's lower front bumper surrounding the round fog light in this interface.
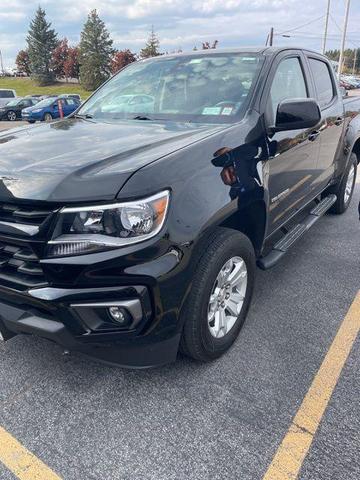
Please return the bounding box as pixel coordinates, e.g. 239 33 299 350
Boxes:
0 285 180 368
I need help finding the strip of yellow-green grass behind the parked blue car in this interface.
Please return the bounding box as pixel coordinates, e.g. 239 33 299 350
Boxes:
0 77 91 100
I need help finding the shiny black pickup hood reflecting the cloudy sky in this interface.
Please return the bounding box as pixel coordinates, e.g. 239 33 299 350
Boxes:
0 118 226 203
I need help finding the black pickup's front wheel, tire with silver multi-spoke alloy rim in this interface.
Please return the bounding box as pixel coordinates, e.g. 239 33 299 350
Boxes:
180 228 256 362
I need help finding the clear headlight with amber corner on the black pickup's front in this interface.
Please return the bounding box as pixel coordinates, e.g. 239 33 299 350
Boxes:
48 190 170 257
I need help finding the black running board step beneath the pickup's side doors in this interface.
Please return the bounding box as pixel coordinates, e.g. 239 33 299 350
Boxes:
257 195 337 270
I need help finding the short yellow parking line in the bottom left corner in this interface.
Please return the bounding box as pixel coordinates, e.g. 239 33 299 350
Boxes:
0 427 61 480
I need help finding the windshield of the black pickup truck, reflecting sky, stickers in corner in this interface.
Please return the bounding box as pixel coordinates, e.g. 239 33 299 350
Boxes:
78 53 263 123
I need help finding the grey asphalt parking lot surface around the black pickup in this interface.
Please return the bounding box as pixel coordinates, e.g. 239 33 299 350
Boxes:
0 127 360 480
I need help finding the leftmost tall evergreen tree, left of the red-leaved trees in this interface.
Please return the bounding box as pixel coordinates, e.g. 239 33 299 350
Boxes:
26 7 57 85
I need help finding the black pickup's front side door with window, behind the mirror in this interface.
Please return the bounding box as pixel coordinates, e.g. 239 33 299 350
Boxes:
265 52 320 235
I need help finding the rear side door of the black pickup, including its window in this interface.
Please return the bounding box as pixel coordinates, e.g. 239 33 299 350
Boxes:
307 54 344 193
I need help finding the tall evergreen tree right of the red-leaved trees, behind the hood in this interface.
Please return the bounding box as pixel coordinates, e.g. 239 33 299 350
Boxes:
79 10 114 90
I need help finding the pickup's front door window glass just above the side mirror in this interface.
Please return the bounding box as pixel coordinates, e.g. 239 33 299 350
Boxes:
268 57 308 121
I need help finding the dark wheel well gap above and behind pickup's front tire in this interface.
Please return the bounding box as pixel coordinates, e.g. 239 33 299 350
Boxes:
220 201 266 255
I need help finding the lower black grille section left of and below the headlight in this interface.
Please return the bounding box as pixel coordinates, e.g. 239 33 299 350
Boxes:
0 240 46 290
